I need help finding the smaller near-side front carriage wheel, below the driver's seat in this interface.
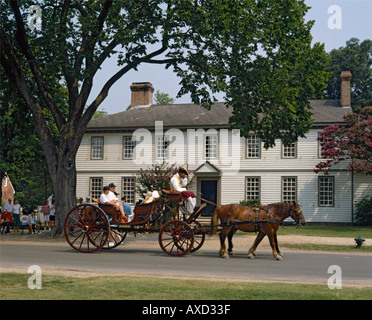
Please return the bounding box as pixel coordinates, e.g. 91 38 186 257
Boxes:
159 220 194 257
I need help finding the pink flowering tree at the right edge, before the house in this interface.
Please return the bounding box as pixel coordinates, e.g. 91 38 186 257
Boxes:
314 107 372 174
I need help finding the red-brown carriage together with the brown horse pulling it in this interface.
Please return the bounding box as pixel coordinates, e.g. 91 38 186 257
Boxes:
64 190 305 260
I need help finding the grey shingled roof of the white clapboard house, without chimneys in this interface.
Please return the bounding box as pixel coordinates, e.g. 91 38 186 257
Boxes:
87 100 351 132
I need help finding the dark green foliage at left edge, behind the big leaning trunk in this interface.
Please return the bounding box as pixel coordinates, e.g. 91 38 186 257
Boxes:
0 74 51 202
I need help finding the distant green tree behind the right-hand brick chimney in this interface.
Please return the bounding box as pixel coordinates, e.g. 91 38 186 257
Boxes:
326 38 372 108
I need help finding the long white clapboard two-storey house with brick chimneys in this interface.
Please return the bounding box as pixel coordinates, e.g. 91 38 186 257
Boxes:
76 72 372 223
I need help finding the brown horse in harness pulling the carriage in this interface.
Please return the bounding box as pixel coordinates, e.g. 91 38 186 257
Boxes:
211 201 305 260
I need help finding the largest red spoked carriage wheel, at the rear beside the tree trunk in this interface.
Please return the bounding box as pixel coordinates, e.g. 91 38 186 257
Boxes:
64 204 110 253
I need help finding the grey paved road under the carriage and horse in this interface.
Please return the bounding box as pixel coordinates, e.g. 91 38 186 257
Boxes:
0 242 372 285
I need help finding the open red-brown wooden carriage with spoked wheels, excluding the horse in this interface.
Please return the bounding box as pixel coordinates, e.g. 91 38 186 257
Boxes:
64 190 209 256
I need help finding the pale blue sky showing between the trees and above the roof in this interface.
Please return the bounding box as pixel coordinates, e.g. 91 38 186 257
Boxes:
88 0 372 114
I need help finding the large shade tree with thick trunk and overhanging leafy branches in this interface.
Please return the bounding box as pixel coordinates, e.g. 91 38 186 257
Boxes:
0 0 328 234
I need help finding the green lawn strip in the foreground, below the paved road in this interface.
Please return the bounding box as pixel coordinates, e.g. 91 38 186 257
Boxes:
0 273 372 300
